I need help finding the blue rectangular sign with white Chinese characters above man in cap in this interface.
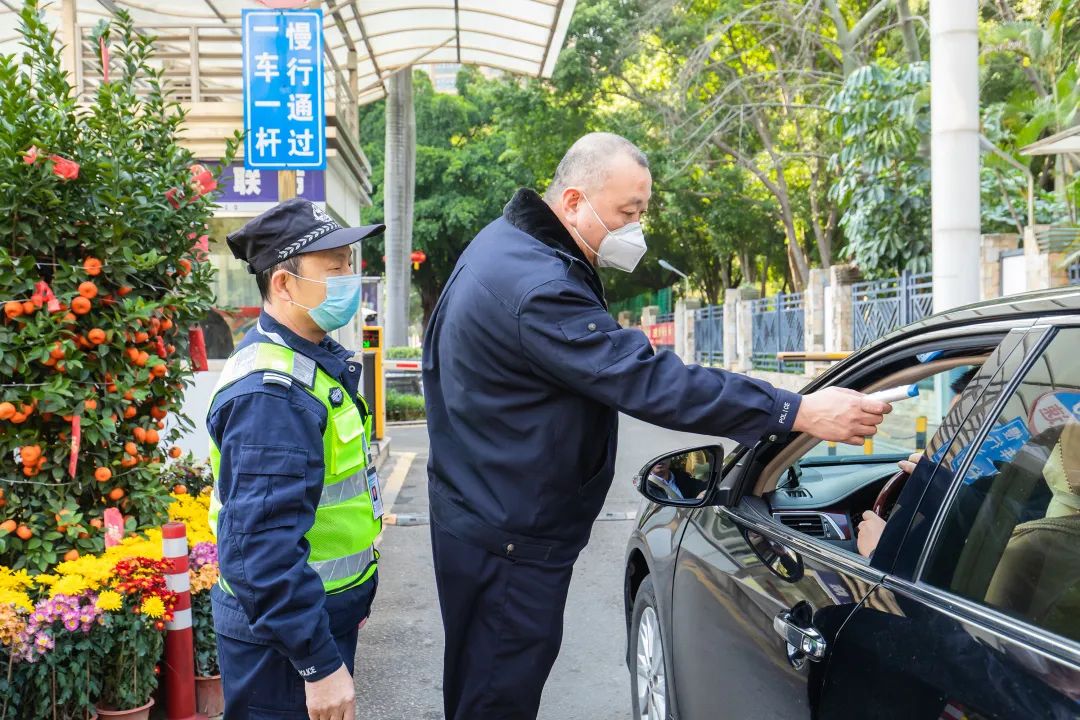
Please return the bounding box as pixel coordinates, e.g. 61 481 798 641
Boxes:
243 10 326 169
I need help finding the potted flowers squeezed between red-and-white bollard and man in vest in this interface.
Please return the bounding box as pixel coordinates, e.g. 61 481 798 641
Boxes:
188 543 225 718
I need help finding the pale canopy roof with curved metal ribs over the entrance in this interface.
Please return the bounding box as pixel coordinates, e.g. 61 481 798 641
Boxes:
0 0 577 104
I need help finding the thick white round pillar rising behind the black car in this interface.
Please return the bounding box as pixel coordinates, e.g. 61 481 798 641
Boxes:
930 0 980 312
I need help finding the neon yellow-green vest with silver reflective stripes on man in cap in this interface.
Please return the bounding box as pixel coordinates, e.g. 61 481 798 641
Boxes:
210 342 382 594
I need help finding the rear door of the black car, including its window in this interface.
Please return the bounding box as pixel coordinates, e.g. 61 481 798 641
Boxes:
820 322 1080 720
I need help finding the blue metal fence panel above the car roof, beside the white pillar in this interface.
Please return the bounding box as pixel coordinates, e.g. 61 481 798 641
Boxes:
851 272 934 348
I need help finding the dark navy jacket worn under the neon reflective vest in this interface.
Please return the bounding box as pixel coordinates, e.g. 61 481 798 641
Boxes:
206 312 377 681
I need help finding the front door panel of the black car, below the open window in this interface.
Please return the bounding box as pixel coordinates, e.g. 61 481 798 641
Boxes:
671 498 881 720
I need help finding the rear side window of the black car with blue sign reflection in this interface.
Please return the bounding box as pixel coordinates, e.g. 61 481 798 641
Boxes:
922 328 1080 640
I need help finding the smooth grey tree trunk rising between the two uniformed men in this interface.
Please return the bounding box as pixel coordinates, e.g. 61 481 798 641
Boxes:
383 68 416 348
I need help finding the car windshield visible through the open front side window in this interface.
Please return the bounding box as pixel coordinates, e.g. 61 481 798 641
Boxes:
802 365 978 463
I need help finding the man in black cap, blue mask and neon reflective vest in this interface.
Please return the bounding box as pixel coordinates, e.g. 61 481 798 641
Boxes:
206 199 384 720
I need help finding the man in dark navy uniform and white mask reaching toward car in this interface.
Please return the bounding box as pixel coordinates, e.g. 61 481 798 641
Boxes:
423 133 889 720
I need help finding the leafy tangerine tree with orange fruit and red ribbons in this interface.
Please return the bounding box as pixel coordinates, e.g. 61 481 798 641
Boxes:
0 0 235 570
